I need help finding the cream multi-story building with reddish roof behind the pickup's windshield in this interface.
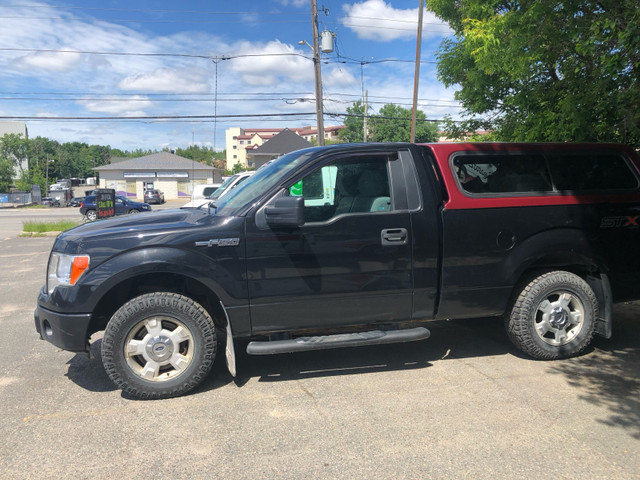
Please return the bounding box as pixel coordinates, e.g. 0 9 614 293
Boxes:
225 125 344 170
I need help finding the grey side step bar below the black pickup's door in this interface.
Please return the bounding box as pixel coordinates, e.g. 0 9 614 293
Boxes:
247 327 431 355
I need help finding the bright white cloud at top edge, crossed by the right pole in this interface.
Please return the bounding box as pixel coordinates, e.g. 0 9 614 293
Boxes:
342 0 452 42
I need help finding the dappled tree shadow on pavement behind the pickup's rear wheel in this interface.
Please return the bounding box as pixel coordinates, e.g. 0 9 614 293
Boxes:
550 302 640 439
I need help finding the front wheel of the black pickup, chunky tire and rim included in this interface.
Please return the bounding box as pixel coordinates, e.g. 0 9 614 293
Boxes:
102 292 217 399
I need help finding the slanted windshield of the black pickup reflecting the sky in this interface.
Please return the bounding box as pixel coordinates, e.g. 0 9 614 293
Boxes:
216 150 315 216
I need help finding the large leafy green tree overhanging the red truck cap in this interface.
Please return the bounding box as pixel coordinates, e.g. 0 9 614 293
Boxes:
427 0 640 145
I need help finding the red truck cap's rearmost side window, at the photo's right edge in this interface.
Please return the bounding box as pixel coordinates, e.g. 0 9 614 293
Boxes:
548 152 638 191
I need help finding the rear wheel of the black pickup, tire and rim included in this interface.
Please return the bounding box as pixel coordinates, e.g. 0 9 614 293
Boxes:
506 271 598 360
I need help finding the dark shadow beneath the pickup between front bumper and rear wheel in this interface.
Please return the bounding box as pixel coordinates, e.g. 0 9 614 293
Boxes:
67 319 519 398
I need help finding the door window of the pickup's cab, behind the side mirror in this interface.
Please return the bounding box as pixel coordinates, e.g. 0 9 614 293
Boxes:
288 155 392 222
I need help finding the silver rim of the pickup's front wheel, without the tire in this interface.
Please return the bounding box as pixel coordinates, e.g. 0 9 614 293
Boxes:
124 316 195 382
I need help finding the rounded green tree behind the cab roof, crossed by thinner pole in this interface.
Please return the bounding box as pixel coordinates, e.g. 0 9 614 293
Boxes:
371 103 438 142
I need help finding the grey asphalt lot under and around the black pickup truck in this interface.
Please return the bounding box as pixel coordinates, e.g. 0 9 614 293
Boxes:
0 207 640 479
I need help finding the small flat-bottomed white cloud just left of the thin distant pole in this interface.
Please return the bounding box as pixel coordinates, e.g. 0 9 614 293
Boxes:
118 68 210 93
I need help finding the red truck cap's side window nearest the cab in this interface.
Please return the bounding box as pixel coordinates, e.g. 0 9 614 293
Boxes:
453 154 553 194
